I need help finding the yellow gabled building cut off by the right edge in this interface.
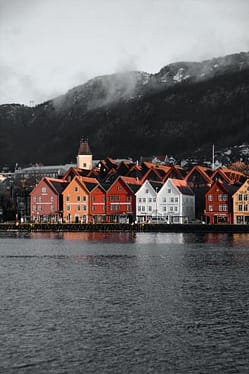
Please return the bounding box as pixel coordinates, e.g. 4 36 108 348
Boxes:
233 179 249 225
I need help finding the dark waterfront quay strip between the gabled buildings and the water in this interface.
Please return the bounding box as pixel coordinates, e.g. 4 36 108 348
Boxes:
0 223 249 233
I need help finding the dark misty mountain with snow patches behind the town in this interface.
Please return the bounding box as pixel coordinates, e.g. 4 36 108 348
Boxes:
0 52 249 166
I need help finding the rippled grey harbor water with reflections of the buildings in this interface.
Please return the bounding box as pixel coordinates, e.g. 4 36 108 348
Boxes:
0 232 249 374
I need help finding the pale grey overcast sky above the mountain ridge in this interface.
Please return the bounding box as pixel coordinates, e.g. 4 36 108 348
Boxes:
0 0 249 105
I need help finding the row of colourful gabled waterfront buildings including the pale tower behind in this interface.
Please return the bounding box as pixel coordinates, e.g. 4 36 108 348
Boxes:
29 140 249 224
